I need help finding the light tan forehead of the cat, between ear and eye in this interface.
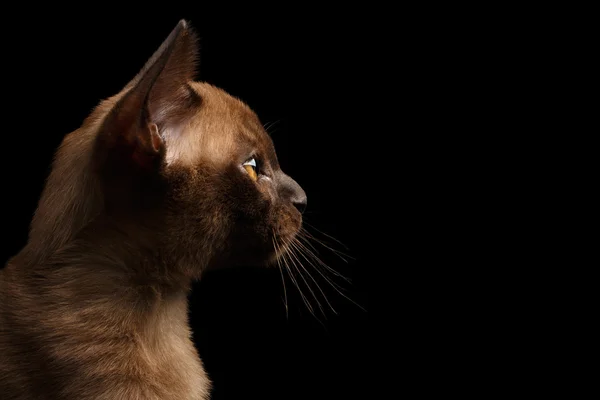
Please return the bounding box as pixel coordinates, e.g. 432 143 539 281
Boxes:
165 82 276 165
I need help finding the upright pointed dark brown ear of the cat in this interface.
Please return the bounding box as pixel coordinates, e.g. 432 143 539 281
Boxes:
97 20 198 167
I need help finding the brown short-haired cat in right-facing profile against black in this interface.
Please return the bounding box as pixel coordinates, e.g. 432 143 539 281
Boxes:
0 21 306 400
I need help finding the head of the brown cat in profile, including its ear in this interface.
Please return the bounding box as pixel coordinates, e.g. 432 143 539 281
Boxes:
30 21 306 276
